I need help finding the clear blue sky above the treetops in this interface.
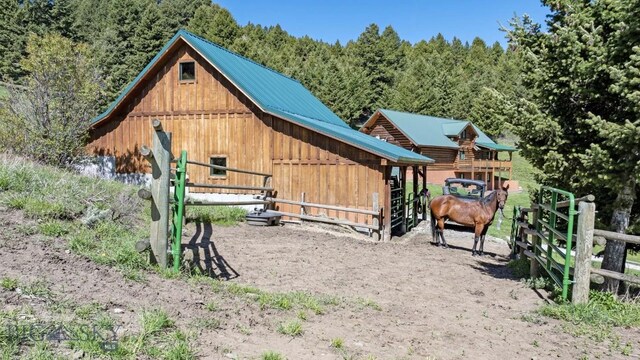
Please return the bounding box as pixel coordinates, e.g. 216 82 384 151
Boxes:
214 0 548 46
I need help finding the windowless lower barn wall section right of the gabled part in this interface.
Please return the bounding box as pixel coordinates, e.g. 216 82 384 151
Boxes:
272 117 385 222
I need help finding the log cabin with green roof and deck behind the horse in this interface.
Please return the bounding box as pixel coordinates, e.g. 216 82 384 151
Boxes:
360 109 518 189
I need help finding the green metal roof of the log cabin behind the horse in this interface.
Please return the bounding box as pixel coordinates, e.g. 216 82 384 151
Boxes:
378 109 517 151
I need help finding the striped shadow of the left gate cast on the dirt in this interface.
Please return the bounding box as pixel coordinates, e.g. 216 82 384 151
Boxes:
183 222 240 280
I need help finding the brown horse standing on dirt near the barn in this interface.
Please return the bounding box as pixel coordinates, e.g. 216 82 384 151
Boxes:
429 185 509 256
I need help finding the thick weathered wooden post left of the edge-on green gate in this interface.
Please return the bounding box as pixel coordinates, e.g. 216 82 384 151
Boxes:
146 119 171 268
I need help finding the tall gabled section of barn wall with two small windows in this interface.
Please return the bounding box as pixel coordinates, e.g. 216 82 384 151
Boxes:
89 45 272 192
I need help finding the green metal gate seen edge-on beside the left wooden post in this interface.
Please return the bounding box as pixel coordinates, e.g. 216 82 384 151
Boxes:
171 150 187 272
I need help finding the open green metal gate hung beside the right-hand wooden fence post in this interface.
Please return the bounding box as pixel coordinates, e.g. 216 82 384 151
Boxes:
532 186 578 300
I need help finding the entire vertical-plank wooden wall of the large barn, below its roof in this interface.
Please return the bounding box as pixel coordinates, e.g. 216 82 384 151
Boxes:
88 40 385 222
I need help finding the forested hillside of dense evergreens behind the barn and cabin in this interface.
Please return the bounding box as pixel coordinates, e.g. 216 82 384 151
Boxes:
0 0 524 135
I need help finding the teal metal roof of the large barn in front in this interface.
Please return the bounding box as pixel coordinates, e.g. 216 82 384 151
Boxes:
92 30 433 164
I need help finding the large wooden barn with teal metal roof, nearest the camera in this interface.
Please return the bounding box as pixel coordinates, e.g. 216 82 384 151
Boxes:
88 30 433 237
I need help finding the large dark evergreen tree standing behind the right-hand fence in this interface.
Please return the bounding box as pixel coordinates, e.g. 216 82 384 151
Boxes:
510 0 640 291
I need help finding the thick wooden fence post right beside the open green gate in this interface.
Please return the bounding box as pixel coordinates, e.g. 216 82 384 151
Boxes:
567 201 596 304
